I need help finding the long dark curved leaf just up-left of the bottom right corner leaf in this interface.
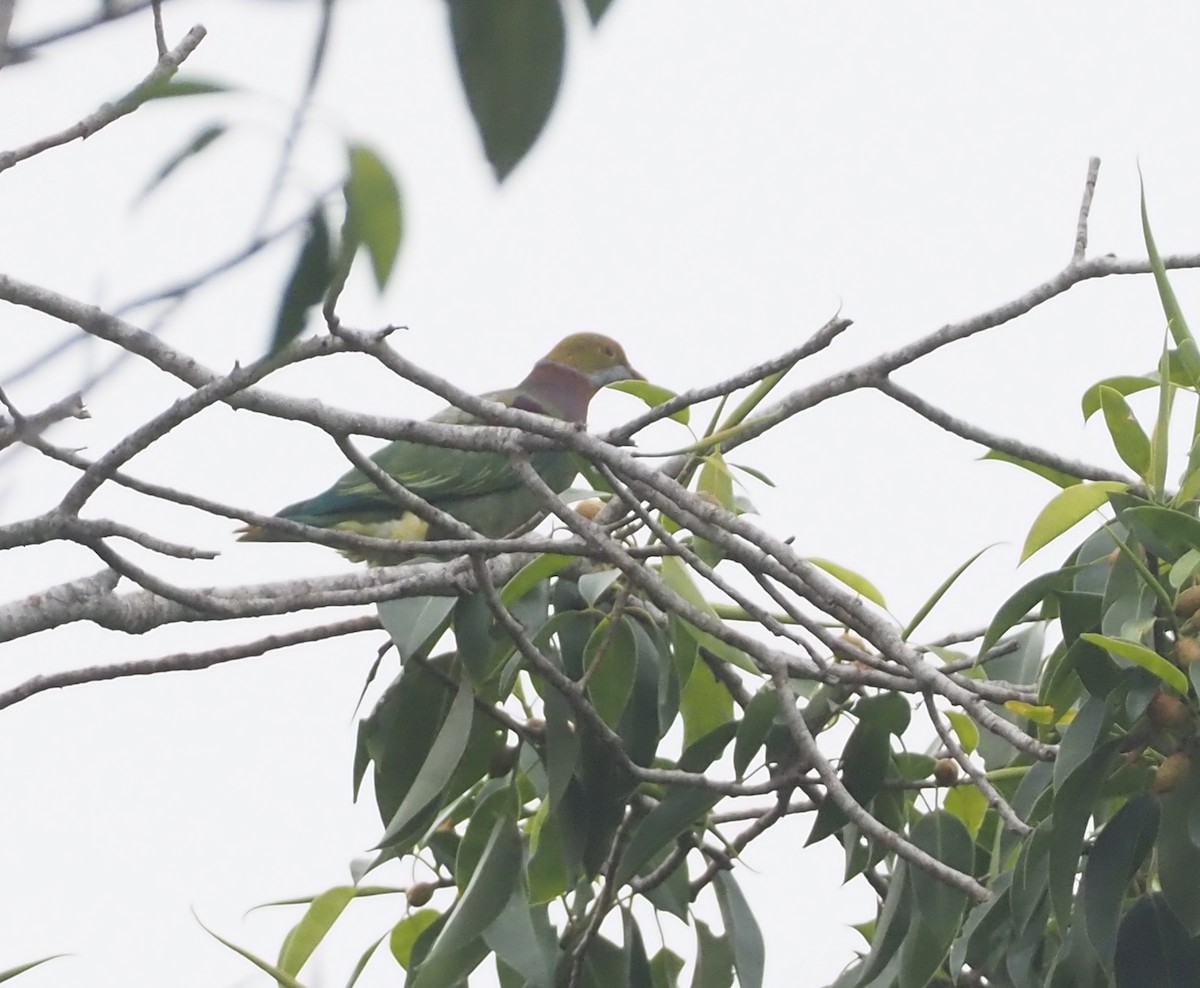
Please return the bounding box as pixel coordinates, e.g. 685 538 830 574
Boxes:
1082 795 1159 970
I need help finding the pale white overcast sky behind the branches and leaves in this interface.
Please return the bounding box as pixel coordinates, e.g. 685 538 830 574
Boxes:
0 0 1200 988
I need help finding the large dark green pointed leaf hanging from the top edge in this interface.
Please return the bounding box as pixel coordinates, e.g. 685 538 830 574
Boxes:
449 0 566 181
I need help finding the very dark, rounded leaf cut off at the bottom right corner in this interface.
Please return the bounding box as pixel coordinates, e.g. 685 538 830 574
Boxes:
1115 893 1200 988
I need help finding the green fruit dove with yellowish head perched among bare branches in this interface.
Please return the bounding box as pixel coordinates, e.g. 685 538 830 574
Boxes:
239 333 646 562
